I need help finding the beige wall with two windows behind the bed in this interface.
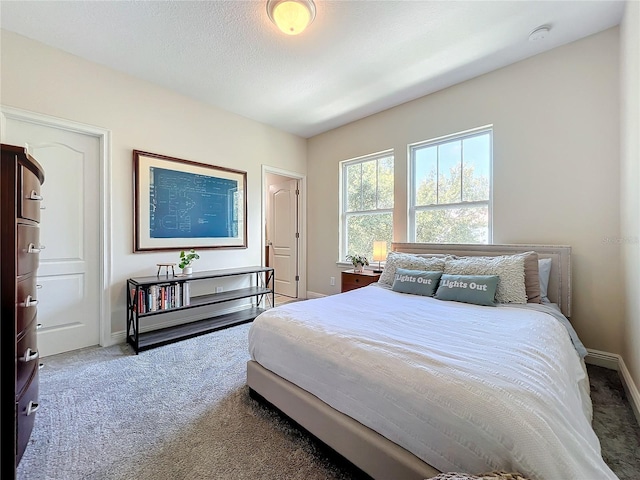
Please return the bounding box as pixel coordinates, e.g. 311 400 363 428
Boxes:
308 28 624 353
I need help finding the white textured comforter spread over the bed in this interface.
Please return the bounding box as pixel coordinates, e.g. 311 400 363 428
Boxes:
249 285 617 480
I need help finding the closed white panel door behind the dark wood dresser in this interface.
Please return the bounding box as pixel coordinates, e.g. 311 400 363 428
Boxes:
3 118 101 356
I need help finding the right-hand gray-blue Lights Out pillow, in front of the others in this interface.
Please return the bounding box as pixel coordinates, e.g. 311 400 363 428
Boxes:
436 273 500 307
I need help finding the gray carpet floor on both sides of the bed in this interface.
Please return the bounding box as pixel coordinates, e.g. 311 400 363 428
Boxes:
18 324 640 480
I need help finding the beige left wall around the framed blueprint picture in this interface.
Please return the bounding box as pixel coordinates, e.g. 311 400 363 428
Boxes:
0 31 306 340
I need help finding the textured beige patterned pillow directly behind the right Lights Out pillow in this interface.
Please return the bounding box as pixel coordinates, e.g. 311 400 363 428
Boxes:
444 254 527 303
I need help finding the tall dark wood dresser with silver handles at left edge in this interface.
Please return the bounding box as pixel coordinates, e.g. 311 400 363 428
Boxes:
0 144 44 478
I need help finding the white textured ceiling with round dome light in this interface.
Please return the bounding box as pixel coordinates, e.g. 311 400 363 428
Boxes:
0 0 624 137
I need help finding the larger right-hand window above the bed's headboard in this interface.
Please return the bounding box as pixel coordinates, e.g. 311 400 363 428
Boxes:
409 127 493 243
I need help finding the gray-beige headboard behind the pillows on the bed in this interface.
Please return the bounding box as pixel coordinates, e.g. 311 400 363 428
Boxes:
391 242 571 318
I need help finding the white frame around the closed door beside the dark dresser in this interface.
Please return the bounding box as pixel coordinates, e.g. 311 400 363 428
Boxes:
0 105 113 347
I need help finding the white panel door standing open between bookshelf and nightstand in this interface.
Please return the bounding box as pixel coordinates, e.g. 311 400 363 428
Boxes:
268 180 299 298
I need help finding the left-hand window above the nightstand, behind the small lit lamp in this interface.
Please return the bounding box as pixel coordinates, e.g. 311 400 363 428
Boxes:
341 151 393 261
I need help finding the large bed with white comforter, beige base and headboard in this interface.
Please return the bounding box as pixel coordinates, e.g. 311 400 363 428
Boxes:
247 243 617 480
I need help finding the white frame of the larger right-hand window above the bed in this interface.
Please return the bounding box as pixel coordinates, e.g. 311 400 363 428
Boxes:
407 125 493 244
